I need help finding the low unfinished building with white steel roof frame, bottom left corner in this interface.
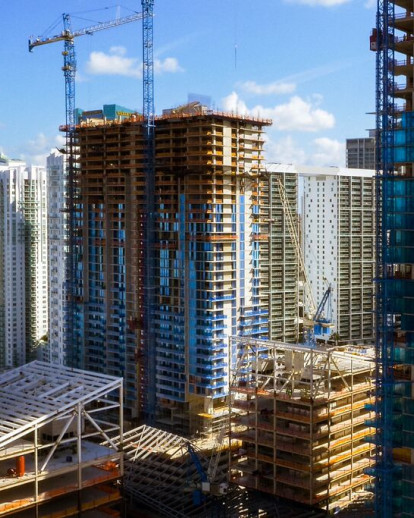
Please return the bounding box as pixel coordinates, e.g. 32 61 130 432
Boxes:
0 361 123 518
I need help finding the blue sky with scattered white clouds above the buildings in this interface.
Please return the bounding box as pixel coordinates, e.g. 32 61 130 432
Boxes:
0 0 376 165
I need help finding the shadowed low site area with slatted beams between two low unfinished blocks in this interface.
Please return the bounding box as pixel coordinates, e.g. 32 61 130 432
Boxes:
115 425 325 518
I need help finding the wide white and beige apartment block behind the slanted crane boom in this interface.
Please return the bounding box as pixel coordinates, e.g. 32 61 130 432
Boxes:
267 164 376 348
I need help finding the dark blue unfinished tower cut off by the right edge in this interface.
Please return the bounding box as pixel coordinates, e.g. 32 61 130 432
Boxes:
371 0 414 518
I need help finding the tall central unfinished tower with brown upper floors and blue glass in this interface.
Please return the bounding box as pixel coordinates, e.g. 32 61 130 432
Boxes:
70 103 269 432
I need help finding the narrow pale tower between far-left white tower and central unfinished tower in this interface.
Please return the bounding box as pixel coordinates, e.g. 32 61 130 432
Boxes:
46 152 68 365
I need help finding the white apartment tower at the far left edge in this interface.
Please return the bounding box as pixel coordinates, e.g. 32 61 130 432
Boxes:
0 155 48 368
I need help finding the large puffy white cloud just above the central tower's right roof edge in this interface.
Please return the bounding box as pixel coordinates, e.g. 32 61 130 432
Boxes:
223 92 335 132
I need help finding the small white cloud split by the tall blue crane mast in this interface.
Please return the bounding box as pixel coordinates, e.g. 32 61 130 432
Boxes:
86 46 183 78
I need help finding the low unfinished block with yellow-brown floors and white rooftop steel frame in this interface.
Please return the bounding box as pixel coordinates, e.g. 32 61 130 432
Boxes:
230 338 375 513
